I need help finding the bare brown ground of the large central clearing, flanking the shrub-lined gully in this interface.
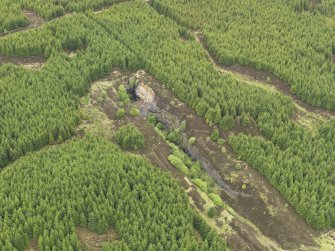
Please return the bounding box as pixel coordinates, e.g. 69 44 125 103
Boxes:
82 70 335 250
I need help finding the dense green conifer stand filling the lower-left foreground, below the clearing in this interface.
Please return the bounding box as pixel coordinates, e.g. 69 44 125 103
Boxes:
0 136 225 251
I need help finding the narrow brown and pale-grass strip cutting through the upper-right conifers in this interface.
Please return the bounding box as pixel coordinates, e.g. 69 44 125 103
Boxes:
193 31 335 119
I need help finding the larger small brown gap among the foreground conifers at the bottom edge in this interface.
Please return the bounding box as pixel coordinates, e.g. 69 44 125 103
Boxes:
77 227 117 251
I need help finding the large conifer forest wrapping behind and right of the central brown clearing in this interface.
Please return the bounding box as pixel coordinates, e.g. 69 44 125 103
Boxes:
0 0 335 231
